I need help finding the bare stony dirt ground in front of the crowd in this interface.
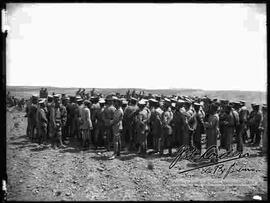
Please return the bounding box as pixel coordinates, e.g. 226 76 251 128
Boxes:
6 109 267 201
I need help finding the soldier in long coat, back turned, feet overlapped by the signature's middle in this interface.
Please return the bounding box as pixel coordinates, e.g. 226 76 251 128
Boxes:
204 104 219 162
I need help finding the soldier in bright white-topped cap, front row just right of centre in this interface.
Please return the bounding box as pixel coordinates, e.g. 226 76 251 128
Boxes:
135 100 151 155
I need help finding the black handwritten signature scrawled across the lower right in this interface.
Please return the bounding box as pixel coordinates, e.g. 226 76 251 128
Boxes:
169 145 253 178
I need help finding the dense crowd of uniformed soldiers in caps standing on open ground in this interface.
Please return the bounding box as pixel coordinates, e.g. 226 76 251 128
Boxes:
26 91 267 159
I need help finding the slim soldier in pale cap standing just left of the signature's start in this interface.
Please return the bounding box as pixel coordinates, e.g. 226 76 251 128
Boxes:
159 98 173 156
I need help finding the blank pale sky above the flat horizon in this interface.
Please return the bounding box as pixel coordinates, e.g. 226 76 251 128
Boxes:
7 3 267 91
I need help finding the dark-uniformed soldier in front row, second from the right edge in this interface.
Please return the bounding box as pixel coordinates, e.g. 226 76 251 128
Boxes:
250 104 262 146
